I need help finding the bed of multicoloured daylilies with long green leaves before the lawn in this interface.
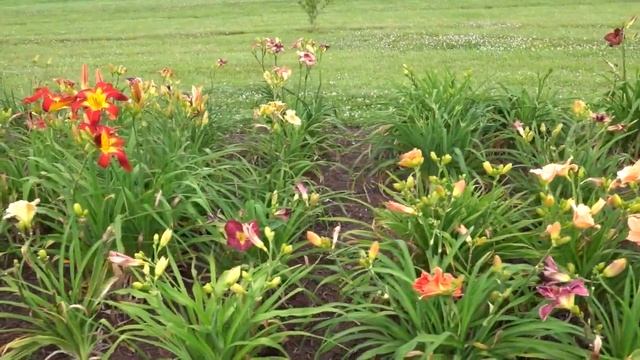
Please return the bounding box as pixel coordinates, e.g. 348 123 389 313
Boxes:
0 18 640 359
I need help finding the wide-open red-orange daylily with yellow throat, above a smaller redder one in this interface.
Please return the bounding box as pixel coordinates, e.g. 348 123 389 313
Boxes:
71 82 129 124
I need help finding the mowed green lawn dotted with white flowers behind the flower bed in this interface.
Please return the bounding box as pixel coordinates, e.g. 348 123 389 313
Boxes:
0 0 640 103
